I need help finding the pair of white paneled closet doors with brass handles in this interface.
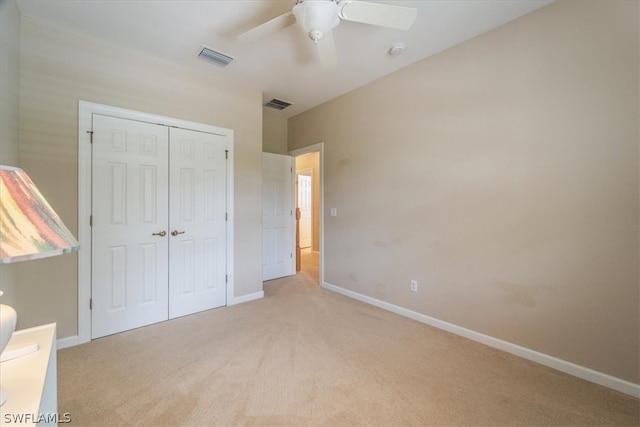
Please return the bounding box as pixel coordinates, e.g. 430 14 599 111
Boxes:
91 114 227 338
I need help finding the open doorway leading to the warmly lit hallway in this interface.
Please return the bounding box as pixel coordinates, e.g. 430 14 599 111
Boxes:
289 143 324 285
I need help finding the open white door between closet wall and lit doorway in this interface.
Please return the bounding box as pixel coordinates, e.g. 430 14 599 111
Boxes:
262 153 295 280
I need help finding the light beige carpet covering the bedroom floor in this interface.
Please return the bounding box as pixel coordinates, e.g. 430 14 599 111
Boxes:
58 273 640 426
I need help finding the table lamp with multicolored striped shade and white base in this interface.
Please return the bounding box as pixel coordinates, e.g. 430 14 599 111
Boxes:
0 165 79 406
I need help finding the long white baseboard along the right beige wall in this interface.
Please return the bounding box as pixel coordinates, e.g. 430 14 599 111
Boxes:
322 282 640 398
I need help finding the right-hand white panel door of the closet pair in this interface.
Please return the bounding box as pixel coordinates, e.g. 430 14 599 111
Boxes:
169 128 227 318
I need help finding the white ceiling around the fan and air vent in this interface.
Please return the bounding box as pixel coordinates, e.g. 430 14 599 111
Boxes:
17 0 552 117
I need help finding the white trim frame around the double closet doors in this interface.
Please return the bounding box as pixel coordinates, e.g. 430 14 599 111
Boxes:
78 100 235 344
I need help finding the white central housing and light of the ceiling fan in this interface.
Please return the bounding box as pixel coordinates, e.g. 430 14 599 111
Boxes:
293 0 340 42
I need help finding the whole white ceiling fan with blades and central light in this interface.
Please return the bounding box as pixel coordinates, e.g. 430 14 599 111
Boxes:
238 0 418 68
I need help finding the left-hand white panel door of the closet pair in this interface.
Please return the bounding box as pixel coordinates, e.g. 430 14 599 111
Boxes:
91 114 169 338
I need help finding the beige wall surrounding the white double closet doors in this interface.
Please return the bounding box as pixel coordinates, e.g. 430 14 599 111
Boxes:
18 18 262 338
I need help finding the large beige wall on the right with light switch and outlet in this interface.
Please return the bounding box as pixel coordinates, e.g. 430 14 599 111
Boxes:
289 1 640 383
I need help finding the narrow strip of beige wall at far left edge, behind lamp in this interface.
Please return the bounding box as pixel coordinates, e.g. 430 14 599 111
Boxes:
0 1 20 307
